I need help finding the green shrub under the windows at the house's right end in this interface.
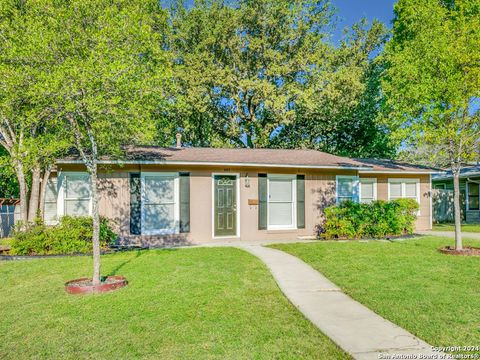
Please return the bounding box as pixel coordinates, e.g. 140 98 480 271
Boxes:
320 199 418 239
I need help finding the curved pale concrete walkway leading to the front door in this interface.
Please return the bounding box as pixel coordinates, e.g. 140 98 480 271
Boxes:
238 245 440 360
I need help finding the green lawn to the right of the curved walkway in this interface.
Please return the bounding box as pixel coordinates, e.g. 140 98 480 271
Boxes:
272 237 480 346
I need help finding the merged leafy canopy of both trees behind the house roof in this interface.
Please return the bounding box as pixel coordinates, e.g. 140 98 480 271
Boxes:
169 0 392 156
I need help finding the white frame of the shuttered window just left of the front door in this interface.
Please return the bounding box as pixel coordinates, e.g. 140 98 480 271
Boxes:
140 171 180 235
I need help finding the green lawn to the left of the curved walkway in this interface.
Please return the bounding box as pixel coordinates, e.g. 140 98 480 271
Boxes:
0 248 348 359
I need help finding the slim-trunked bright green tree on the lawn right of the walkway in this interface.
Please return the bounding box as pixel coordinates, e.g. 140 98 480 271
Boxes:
383 0 480 250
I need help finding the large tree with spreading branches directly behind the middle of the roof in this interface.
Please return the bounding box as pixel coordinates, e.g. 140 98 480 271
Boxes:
170 0 332 147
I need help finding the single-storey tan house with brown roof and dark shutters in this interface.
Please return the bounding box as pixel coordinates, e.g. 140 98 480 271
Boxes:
45 147 433 246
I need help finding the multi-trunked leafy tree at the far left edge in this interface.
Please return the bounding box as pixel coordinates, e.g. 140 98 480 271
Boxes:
0 0 69 223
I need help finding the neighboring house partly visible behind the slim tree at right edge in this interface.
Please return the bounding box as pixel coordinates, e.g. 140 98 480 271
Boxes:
432 165 480 222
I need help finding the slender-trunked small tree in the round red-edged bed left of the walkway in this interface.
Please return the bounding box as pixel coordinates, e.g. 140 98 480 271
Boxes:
43 0 170 285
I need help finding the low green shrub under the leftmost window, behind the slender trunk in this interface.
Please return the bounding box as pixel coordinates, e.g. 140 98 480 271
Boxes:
11 216 116 255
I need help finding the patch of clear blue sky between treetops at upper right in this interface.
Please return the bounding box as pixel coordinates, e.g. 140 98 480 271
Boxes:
331 0 396 40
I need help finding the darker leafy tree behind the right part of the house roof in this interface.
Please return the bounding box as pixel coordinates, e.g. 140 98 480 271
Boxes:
272 20 395 157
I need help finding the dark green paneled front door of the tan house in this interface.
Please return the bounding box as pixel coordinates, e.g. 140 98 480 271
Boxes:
214 175 237 236
